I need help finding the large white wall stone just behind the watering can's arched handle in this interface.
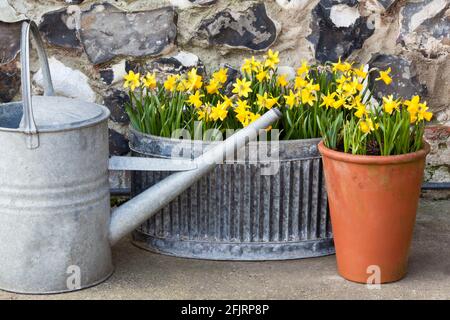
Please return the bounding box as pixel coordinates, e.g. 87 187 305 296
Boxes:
33 57 95 102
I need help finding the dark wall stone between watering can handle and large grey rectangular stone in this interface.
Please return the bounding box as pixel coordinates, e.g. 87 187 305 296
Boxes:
39 8 81 49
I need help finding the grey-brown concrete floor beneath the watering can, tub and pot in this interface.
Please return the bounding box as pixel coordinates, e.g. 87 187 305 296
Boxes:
0 200 450 299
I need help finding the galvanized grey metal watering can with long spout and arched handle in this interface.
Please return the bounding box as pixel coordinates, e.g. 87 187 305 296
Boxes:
0 22 280 294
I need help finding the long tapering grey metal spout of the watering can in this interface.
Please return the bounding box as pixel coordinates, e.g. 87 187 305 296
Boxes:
109 108 281 245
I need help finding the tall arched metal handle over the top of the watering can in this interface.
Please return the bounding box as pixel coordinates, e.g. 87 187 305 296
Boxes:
20 21 54 149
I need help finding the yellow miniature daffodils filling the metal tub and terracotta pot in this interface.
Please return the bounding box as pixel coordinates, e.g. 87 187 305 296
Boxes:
124 50 433 155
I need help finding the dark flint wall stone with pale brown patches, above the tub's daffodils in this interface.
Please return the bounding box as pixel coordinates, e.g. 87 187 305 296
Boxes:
197 3 277 50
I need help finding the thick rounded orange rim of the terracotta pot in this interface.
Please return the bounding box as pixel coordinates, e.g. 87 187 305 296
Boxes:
318 141 430 164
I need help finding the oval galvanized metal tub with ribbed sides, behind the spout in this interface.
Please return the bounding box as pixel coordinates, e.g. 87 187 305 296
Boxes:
130 129 334 260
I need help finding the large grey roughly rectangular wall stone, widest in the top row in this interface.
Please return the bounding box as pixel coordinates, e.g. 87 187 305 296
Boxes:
80 3 177 64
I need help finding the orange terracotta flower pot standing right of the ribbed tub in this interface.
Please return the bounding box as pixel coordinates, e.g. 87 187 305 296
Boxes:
319 142 430 283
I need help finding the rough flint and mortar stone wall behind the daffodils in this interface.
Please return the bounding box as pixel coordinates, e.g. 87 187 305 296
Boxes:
0 0 450 185
